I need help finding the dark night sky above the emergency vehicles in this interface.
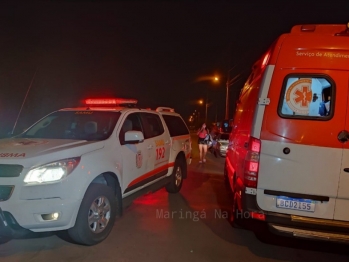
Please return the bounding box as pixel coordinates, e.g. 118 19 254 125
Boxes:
0 0 349 137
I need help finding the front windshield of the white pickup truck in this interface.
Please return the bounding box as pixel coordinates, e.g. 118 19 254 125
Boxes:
19 111 120 141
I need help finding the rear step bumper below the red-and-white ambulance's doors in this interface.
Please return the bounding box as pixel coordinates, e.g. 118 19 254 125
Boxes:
269 224 349 244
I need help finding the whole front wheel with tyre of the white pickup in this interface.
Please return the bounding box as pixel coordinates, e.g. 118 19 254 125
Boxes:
68 184 119 246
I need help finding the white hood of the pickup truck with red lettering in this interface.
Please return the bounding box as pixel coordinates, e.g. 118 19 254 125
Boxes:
0 138 104 167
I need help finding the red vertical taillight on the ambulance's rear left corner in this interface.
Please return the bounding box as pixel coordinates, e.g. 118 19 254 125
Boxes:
244 137 261 188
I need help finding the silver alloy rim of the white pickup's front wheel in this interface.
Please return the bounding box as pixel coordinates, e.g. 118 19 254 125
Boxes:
88 196 111 234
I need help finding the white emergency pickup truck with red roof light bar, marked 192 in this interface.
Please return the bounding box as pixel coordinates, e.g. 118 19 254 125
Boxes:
0 99 191 245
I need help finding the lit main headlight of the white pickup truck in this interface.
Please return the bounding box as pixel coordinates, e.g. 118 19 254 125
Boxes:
24 157 80 184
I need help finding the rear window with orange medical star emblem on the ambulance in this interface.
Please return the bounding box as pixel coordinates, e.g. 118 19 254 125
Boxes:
278 75 334 119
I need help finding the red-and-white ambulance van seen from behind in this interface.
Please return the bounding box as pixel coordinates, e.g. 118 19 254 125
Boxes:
224 24 349 242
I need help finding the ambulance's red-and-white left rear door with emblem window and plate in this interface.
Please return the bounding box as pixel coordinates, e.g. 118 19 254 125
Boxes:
257 68 349 219
